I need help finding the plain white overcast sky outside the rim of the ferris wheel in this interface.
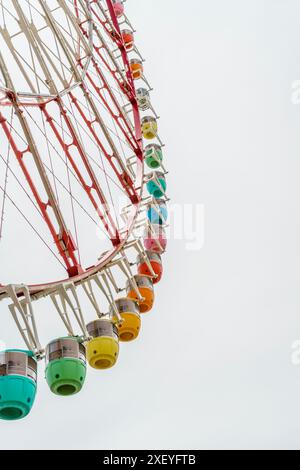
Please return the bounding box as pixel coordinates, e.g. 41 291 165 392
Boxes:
0 0 300 449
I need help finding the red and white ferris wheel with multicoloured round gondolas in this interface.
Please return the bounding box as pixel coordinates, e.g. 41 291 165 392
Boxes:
0 0 168 420
